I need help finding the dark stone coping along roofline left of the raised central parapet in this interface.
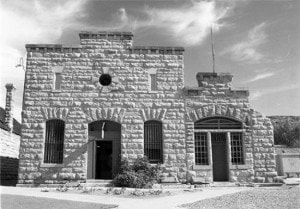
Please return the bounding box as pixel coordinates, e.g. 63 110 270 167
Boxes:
25 44 82 52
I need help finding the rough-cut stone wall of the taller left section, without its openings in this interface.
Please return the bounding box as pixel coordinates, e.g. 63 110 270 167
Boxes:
19 33 186 184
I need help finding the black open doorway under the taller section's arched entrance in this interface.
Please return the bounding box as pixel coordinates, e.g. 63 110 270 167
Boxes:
95 141 112 179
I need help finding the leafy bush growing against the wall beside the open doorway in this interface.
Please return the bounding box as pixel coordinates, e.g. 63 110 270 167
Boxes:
113 157 159 188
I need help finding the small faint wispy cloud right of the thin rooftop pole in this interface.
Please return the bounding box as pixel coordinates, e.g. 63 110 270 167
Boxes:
221 22 268 63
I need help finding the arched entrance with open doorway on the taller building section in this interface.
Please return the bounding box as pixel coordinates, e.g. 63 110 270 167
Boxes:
87 120 121 179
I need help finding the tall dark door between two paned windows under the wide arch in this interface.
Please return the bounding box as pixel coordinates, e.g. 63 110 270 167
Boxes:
211 133 228 181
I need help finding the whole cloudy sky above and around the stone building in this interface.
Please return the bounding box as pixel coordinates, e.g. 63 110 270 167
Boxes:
0 0 300 120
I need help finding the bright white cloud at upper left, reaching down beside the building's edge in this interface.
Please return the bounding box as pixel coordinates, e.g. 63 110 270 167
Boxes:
0 0 88 120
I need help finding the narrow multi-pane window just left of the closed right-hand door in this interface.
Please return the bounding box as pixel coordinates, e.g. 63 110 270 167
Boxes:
195 132 208 165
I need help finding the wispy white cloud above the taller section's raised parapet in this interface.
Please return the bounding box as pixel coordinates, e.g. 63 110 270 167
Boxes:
105 1 231 46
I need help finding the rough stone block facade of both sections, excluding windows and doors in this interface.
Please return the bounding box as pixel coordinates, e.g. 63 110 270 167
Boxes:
19 32 276 184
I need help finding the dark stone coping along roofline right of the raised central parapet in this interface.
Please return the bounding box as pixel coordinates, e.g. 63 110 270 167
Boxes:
129 46 184 55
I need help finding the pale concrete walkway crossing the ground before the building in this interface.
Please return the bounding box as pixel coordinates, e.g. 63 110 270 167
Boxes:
0 186 251 209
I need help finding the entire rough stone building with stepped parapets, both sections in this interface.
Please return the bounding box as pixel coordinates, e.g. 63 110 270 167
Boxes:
19 32 276 184
